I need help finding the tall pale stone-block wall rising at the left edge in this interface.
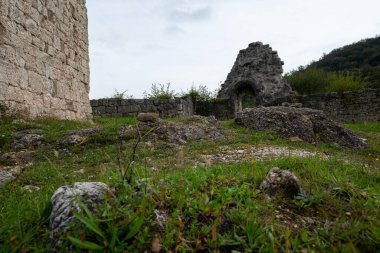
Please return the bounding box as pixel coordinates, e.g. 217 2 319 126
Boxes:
0 0 91 119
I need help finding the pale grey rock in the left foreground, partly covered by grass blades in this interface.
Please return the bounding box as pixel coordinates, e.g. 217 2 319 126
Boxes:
50 182 113 245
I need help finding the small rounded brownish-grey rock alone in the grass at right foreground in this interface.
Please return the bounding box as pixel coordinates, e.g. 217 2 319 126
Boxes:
260 167 303 198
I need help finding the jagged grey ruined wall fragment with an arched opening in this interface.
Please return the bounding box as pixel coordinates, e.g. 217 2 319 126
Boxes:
218 42 292 113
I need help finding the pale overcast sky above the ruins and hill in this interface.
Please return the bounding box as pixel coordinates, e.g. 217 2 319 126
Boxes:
87 0 380 99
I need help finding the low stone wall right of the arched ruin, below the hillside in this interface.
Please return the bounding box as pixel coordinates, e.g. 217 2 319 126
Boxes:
296 89 380 123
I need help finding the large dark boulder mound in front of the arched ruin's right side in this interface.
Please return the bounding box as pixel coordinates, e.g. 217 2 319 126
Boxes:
235 106 367 148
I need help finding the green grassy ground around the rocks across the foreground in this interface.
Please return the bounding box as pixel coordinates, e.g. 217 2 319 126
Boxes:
0 118 380 252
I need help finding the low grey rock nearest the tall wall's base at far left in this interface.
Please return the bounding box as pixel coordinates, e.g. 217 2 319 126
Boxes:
12 129 44 150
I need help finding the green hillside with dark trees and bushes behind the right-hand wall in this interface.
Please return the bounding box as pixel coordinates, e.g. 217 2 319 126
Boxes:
285 37 380 94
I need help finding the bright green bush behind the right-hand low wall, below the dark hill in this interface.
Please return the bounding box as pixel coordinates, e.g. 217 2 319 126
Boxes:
284 67 366 94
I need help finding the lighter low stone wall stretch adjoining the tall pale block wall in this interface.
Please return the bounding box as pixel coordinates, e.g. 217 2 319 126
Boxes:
91 98 194 117
